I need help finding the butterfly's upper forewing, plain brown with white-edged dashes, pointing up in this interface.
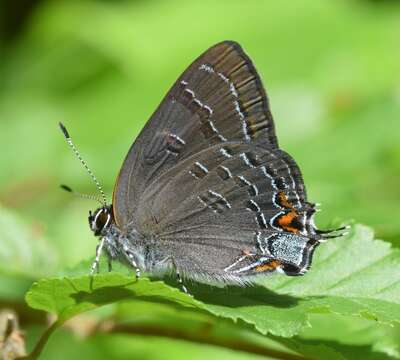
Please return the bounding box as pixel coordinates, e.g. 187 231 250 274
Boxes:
113 41 278 228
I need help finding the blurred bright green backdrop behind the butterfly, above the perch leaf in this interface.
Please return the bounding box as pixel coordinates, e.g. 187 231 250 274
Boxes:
0 0 400 358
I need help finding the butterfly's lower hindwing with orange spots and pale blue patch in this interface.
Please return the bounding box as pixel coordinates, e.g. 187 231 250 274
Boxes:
137 142 320 283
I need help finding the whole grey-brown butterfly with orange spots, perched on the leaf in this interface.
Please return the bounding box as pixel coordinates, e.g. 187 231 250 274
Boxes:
60 41 344 290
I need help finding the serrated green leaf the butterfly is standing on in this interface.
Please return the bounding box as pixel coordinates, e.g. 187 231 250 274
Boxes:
26 225 400 337
